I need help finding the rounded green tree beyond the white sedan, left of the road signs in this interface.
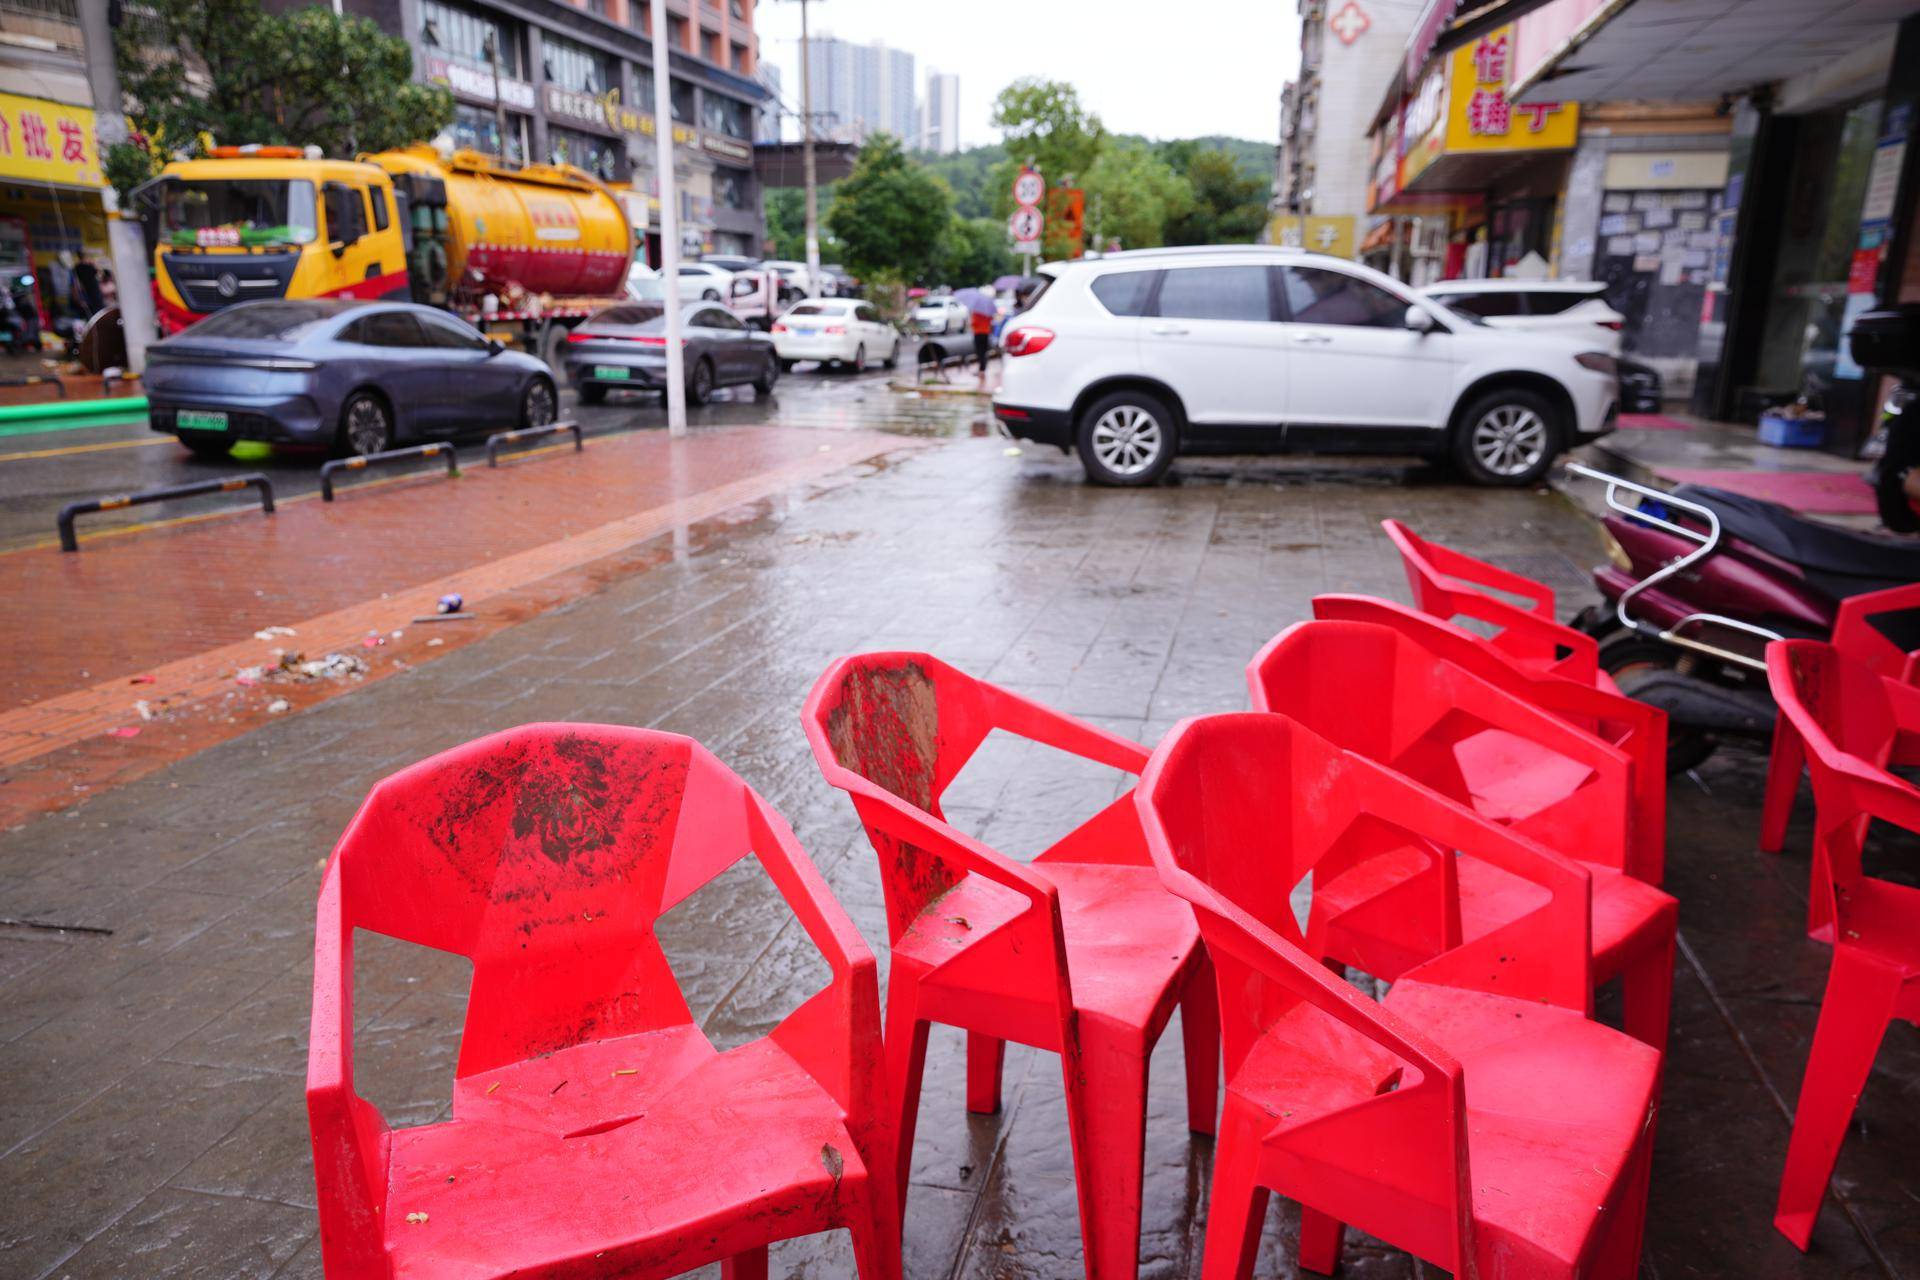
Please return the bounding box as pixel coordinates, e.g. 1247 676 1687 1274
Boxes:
826 132 952 284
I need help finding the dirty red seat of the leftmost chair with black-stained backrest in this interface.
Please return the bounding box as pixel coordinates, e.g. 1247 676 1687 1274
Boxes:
386 1029 866 1280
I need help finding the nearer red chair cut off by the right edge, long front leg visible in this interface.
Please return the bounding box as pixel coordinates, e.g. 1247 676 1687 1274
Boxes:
1766 641 1920 1249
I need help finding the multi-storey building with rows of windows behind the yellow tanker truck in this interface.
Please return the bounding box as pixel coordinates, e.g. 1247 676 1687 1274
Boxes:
346 0 774 263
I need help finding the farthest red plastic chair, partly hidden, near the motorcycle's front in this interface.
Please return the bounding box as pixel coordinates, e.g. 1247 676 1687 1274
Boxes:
1380 520 1620 693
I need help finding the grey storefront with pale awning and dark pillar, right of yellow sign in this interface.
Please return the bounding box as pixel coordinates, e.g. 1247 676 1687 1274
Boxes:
1517 0 1920 453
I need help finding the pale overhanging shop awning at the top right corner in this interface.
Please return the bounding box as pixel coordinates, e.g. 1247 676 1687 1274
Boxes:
1507 0 1920 102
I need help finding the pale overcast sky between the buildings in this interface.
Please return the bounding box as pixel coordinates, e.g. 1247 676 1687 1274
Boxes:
755 0 1300 146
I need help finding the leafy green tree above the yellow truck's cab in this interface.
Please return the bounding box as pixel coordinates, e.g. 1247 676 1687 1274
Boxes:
108 0 453 197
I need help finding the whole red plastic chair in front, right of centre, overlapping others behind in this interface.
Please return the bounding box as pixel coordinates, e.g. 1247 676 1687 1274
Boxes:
1139 714 1661 1280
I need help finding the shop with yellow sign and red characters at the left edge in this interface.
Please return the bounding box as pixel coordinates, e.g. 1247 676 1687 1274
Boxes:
0 94 113 345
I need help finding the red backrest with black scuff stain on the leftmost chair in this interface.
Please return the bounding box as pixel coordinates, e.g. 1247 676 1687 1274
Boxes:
334 723 772 1077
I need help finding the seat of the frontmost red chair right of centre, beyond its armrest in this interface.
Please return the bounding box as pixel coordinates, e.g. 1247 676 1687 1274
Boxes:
1384 981 1661 1276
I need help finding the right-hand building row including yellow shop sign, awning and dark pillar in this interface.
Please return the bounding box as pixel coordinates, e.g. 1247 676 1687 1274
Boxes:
1369 0 1920 441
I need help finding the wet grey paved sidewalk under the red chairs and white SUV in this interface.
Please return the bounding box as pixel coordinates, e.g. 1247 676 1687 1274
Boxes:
0 433 1920 1280
